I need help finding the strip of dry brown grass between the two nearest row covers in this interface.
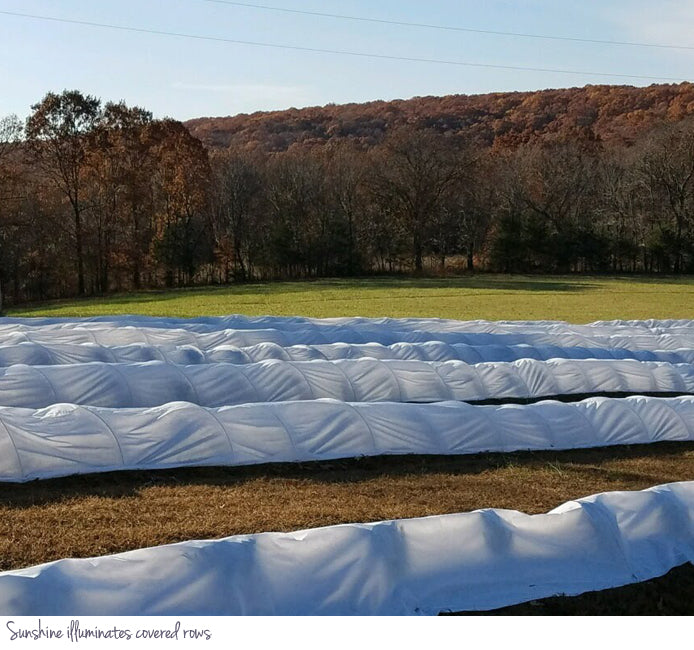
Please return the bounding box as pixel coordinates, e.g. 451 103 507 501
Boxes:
0 443 694 570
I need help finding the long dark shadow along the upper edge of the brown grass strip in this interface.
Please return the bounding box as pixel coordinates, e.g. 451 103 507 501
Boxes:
0 442 694 509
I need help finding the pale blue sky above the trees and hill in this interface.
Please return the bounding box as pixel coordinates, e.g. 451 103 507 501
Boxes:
0 0 694 119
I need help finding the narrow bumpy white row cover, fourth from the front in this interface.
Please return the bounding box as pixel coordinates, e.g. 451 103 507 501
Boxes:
0 341 694 367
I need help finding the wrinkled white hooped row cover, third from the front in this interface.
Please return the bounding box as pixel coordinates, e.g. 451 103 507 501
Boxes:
0 358 694 408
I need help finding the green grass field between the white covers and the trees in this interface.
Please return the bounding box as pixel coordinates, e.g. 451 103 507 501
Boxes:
8 275 694 323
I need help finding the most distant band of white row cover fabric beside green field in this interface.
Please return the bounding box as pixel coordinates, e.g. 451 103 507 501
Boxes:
0 316 694 350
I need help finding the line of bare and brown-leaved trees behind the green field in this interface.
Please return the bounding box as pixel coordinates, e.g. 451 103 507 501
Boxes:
0 91 694 302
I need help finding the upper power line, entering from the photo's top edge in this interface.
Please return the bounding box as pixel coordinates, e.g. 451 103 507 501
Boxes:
201 0 694 50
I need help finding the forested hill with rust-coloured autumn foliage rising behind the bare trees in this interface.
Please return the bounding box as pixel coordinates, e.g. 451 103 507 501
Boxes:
186 83 694 151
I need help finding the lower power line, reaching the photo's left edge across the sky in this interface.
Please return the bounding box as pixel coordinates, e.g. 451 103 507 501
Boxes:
0 11 684 82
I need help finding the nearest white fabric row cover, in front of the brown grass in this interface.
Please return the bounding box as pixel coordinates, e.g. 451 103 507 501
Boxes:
0 482 694 616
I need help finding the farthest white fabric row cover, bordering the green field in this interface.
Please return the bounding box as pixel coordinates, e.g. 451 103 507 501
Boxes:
0 319 694 350
